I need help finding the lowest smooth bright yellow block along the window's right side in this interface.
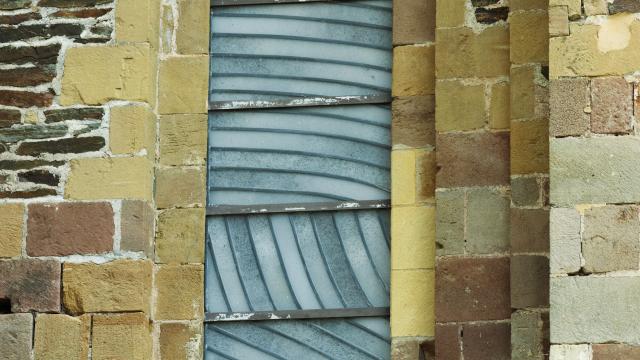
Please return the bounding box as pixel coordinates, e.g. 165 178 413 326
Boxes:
391 269 435 338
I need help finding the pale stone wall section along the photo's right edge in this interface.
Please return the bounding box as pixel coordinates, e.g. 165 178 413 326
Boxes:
549 0 640 360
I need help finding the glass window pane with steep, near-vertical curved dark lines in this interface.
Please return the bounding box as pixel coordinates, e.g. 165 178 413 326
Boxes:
206 210 389 313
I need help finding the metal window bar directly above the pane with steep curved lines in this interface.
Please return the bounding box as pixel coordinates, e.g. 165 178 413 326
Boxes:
207 200 391 215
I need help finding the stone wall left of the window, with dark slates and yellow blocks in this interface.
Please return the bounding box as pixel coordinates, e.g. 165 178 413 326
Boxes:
0 0 209 360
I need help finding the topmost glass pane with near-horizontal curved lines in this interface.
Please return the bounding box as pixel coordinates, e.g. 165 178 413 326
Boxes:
210 0 392 101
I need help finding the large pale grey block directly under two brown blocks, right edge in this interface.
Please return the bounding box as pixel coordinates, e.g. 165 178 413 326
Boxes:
550 136 640 205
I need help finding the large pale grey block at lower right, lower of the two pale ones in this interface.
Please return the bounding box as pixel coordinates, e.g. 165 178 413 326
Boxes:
550 276 640 344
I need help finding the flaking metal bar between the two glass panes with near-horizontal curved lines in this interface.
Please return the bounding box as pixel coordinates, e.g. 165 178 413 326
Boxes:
209 95 391 111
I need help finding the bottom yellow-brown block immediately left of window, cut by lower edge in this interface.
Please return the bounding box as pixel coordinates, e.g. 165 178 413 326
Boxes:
159 323 203 360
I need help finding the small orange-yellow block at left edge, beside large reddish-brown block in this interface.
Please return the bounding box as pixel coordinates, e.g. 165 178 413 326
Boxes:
0 204 24 258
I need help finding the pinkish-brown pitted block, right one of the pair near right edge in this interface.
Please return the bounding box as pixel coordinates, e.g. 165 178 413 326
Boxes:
591 77 633 134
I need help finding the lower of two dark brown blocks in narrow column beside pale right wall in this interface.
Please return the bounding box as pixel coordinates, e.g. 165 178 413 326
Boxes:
511 255 549 309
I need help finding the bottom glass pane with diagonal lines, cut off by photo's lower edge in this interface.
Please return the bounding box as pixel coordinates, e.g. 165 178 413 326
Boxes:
205 317 390 360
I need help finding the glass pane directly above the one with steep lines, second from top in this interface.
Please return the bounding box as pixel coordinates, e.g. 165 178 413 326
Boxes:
208 105 391 205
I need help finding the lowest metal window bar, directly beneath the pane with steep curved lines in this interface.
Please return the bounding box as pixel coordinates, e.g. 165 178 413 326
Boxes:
204 308 389 323
